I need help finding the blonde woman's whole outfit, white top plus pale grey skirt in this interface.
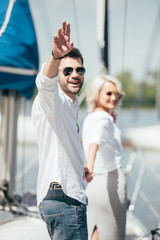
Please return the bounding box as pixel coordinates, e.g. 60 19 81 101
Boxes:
82 111 126 240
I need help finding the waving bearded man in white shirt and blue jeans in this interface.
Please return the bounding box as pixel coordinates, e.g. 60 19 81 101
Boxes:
32 21 92 240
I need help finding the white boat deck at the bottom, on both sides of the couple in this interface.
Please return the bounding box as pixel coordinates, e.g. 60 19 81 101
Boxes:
0 212 149 240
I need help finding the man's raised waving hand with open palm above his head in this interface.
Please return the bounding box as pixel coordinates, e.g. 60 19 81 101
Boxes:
53 21 73 58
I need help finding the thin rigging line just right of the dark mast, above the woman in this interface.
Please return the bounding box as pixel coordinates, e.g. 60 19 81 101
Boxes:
122 0 128 82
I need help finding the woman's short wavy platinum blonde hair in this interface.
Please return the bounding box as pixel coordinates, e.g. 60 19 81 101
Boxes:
86 75 125 111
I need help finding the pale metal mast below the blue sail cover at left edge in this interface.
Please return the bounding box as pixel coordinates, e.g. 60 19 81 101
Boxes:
0 90 20 196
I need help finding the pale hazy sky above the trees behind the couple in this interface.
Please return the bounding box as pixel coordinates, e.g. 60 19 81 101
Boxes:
29 0 160 81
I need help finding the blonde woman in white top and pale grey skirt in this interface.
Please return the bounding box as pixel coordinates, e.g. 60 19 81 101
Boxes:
82 75 126 240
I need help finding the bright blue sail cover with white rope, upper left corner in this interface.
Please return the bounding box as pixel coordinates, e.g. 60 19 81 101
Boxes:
0 0 39 99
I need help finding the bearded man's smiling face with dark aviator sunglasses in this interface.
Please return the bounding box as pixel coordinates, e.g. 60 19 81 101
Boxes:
58 57 84 101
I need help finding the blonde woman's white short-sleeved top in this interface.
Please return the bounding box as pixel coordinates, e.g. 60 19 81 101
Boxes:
82 111 122 174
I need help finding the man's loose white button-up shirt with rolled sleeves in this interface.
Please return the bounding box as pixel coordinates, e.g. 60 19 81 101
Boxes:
32 66 86 205
